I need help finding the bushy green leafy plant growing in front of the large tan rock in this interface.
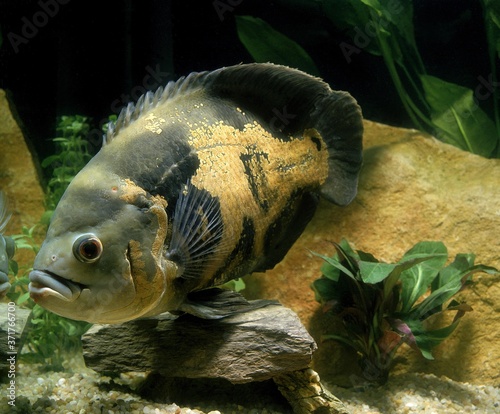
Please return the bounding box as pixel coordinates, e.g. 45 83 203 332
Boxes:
312 240 498 384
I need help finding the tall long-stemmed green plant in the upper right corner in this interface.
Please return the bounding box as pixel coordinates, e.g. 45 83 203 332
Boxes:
325 0 500 157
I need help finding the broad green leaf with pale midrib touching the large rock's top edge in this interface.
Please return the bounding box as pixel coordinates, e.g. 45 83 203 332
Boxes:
420 75 499 157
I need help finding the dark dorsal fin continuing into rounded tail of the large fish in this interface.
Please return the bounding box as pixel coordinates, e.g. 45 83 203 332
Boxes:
104 63 363 205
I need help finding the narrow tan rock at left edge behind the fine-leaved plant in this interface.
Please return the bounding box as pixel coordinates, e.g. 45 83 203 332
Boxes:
0 89 44 263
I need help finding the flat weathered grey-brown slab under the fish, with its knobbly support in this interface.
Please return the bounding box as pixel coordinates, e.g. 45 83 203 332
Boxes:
82 302 347 414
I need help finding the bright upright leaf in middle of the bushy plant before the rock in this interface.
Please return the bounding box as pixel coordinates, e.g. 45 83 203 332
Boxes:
400 242 448 313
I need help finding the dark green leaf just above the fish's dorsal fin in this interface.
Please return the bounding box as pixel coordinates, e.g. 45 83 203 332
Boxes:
236 16 319 76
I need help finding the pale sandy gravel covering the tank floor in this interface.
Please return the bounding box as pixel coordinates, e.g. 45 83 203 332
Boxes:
0 358 500 414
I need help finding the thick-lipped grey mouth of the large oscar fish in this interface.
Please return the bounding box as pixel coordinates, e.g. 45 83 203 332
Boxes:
28 270 86 302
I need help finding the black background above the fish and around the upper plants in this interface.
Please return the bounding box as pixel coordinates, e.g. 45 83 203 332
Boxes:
0 0 489 167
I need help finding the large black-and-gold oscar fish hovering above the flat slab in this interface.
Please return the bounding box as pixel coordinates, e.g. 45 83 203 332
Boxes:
29 64 363 323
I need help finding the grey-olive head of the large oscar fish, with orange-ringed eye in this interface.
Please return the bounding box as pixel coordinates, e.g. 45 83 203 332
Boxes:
29 168 176 323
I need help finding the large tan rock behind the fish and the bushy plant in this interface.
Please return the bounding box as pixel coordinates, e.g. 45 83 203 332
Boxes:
247 121 500 385
